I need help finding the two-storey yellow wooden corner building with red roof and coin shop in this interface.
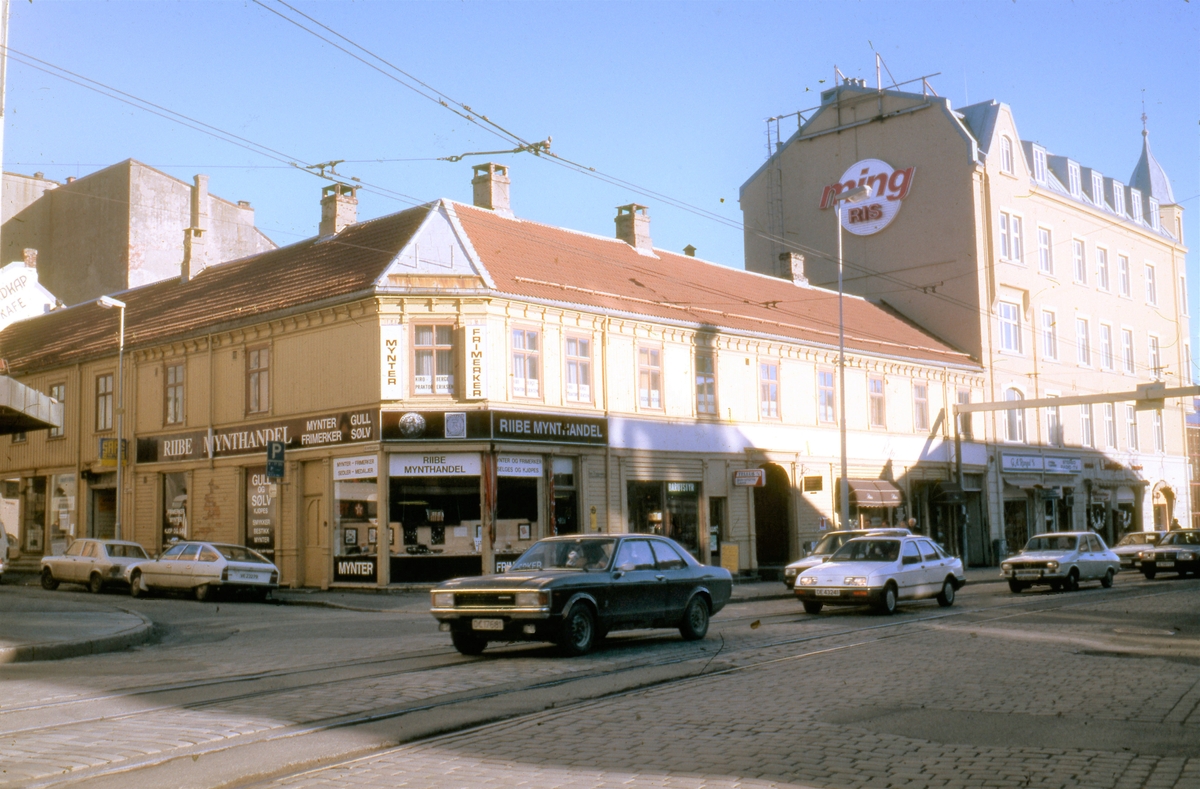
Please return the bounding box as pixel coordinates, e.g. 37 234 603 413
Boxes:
0 164 988 586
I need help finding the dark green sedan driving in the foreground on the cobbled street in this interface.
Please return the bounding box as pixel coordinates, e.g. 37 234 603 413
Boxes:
430 535 733 655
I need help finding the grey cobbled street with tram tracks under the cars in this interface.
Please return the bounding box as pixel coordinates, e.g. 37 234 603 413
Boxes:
0 576 1200 789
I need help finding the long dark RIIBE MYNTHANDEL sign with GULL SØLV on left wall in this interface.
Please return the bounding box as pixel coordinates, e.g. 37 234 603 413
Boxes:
138 409 379 463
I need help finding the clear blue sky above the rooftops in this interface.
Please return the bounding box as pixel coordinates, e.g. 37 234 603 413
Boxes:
4 0 1200 330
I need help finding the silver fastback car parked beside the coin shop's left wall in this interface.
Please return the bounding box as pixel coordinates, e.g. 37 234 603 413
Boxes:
127 542 280 600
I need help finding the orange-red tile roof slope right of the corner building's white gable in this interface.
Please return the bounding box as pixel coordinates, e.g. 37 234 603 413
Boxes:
452 203 977 367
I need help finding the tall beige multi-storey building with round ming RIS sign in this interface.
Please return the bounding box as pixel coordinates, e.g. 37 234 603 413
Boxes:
740 80 1192 548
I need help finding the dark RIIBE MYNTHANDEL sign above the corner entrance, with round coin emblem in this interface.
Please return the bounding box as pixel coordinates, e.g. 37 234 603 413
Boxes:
380 410 608 446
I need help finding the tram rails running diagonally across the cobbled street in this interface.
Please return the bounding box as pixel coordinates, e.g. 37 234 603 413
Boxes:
9 577 1190 787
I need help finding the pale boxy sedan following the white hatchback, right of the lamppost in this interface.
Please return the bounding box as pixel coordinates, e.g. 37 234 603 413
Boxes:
1000 531 1121 594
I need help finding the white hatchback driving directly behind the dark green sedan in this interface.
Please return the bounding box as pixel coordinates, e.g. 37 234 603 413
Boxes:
794 535 967 614
